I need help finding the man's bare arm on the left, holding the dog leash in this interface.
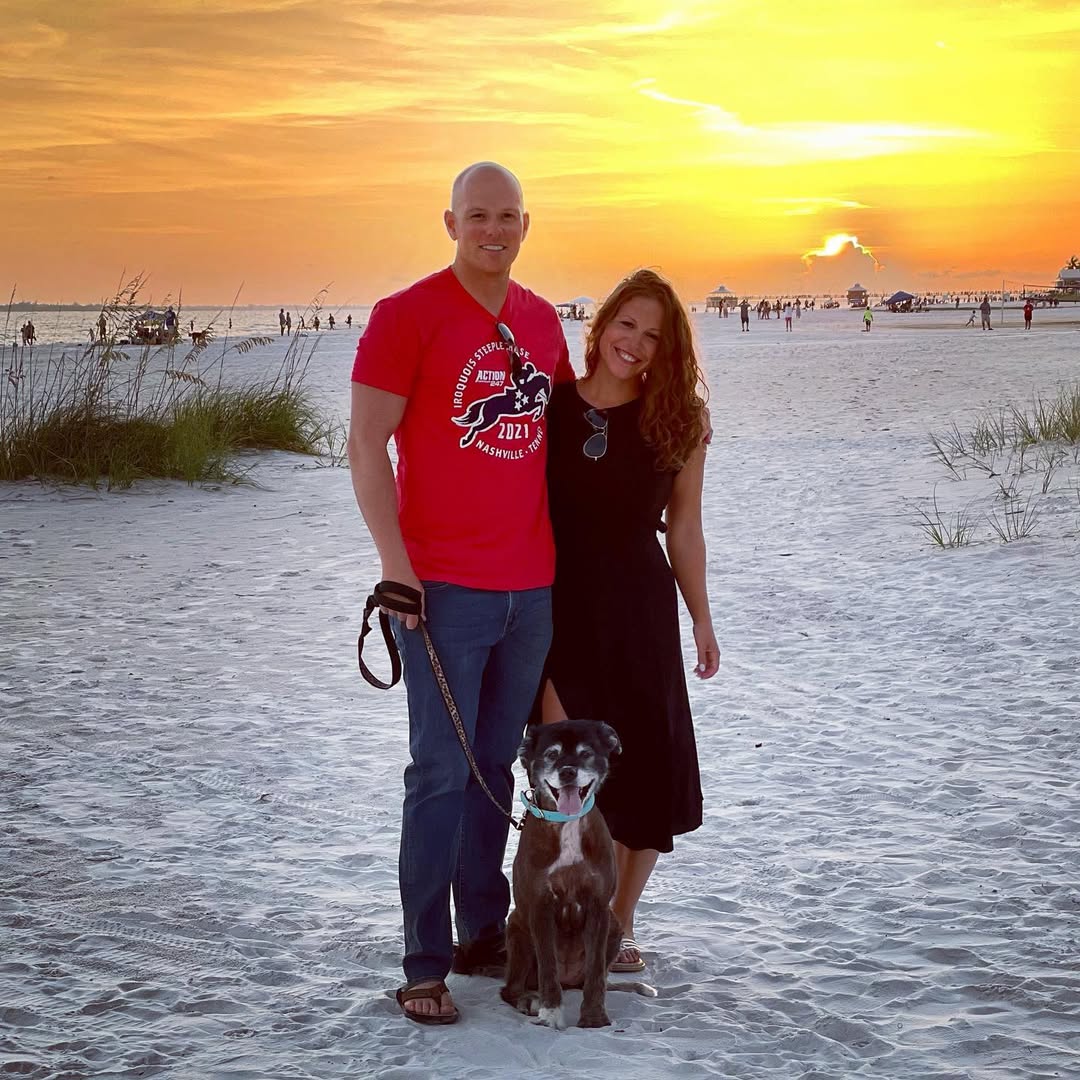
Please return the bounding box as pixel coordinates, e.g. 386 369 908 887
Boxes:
349 382 423 630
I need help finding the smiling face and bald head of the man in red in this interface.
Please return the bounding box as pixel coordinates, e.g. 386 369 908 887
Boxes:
444 168 529 275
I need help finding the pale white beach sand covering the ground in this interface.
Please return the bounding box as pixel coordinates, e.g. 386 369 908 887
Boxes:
0 311 1080 1080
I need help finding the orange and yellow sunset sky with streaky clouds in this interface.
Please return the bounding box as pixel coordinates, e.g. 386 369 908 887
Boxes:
0 0 1080 305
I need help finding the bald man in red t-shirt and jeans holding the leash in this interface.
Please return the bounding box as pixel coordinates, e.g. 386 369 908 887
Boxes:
349 162 573 1024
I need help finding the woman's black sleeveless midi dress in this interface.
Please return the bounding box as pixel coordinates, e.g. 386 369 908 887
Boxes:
545 382 701 851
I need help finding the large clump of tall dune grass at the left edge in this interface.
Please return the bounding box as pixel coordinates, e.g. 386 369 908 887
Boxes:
0 279 333 489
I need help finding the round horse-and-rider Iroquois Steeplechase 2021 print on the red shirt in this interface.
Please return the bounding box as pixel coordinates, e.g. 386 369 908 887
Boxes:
450 342 551 459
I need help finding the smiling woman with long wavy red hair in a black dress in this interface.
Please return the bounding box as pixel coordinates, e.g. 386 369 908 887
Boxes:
541 270 719 971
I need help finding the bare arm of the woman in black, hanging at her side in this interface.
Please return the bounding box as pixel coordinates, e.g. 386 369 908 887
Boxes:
666 445 720 678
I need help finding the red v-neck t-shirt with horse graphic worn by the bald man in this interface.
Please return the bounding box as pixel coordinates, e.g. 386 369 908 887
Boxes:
352 268 573 590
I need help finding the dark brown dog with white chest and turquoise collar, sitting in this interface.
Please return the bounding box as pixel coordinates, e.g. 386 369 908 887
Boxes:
499 720 622 1029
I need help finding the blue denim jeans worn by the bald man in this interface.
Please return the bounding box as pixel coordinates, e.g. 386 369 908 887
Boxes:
394 581 551 982
